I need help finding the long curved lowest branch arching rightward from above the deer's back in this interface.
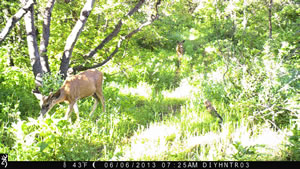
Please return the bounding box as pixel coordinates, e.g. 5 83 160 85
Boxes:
73 0 161 73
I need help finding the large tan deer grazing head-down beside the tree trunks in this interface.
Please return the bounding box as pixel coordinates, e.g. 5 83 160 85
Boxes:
34 69 105 119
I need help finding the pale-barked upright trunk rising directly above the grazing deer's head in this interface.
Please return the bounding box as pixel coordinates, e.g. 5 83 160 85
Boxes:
21 0 43 87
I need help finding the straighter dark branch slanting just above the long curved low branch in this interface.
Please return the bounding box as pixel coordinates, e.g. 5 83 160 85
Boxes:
84 0 145 59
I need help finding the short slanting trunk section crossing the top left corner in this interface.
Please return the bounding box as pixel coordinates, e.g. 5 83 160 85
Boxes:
0 0 34 44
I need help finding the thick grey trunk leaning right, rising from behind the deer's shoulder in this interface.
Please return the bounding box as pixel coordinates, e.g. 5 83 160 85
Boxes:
60 0 95 78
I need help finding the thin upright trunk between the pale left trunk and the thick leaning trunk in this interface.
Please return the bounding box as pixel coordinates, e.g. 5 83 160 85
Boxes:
40 0 55 72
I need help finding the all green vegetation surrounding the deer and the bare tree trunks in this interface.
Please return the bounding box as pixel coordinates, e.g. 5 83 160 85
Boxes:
0 0 300 161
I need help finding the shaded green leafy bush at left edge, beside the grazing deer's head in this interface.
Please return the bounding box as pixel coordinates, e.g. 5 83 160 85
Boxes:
0 59 38 123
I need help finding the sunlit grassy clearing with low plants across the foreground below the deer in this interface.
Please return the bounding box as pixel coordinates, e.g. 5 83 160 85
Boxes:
0 74 299 161
